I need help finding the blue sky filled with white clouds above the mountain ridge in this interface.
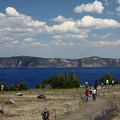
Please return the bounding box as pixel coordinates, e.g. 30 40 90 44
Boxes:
0 0 120 59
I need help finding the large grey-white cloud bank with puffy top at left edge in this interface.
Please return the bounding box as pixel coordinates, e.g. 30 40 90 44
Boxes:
0 7 46 39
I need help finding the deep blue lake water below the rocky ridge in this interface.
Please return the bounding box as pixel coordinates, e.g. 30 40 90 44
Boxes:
0 67 120 88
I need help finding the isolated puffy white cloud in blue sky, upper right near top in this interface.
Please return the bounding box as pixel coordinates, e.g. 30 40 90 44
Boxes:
74 1 104 14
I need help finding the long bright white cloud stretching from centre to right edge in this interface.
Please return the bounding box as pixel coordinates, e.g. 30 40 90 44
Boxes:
46 16 120 34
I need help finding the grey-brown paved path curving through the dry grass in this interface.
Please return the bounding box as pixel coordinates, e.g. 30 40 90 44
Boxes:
59 97 116 120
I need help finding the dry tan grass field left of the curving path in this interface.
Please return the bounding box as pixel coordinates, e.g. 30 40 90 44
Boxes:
0 90 83 120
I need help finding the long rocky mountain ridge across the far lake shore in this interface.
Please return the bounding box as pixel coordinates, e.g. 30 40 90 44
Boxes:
0 56 120 68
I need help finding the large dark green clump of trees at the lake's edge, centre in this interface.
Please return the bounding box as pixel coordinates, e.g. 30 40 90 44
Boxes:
42 71 80 88
